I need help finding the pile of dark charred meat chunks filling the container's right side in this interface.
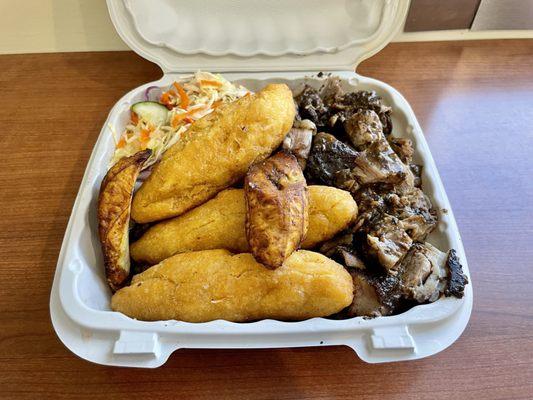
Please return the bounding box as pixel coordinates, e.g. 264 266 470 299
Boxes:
297 78 467 317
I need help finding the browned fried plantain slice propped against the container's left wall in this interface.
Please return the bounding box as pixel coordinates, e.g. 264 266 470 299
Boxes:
98 149 152 291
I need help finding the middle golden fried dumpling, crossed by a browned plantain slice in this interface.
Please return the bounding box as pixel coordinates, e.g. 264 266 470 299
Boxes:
130 185 357 265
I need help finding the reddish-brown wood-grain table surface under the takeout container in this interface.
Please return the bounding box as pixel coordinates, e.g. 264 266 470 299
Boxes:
0 40 533 400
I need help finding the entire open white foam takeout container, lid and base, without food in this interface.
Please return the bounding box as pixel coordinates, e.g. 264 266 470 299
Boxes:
50 0 473 368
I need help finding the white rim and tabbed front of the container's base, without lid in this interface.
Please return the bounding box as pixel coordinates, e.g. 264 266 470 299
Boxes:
50 72 473 367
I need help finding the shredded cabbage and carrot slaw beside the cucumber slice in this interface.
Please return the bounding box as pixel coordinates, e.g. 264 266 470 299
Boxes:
110 71 250 168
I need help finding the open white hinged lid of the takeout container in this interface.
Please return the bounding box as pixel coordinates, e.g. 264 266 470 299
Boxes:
107 0 409 72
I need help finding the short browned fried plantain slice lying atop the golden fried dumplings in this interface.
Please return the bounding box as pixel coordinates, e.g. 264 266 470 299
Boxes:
244 151 309 269
